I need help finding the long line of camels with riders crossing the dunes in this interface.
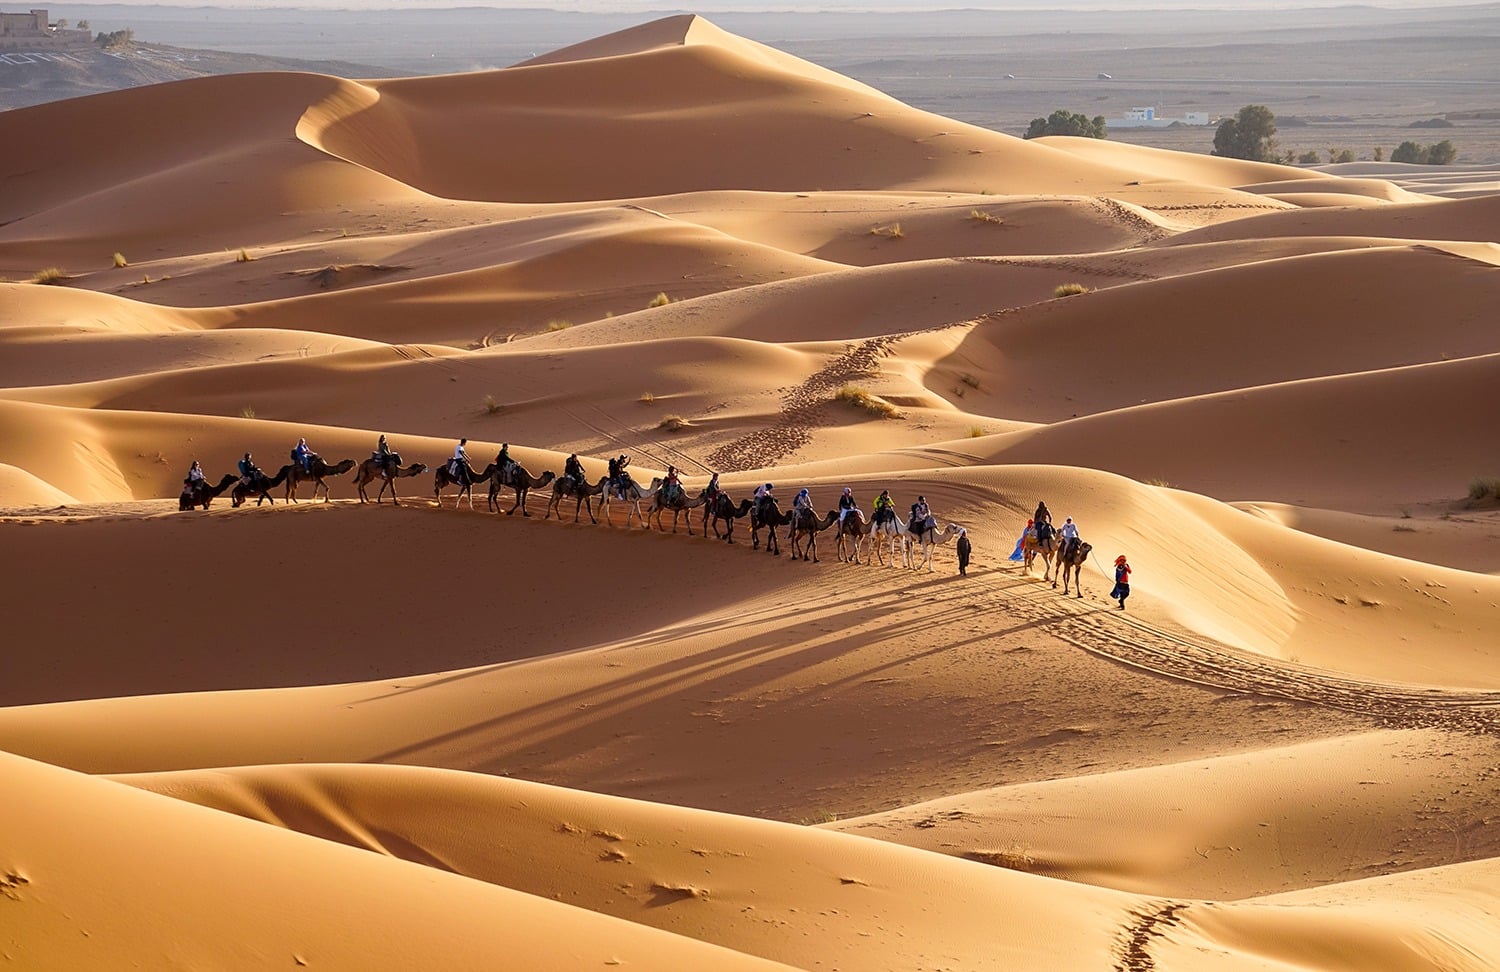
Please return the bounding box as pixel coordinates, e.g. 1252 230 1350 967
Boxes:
177 435 1116 582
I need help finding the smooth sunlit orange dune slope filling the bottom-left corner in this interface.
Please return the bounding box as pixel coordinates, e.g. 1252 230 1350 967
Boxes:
0 755 798 969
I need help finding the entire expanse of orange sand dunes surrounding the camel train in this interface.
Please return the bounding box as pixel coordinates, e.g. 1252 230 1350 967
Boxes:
0 15 1500 972
